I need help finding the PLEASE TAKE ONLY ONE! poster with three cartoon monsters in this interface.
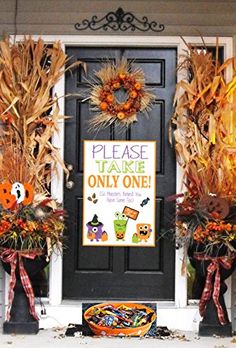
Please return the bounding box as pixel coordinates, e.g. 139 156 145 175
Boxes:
83 141 156 247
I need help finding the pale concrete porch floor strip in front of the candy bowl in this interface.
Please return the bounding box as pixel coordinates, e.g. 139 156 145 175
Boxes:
0 328 236 348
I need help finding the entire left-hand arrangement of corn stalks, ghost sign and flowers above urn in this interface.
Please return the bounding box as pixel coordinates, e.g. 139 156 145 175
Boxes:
0 37 81 254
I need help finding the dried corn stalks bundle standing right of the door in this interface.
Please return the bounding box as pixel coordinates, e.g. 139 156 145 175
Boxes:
172 41 236 203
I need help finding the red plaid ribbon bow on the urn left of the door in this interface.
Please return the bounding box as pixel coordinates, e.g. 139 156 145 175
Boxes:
0 248 42 321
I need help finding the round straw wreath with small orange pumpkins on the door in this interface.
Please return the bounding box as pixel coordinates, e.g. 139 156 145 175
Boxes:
89 59 155 130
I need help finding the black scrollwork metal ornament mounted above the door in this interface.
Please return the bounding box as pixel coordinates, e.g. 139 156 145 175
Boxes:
74 7 165 33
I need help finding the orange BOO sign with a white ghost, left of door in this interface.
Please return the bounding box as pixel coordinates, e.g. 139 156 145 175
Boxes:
0 182 34 209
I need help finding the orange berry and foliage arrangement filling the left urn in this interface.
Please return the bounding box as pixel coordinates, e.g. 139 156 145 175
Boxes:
0 199 64 253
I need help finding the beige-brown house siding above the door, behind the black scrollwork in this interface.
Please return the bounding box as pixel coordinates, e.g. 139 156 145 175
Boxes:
0 0 236 36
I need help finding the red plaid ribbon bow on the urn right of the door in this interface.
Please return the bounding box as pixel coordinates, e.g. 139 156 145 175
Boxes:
194 253 235 325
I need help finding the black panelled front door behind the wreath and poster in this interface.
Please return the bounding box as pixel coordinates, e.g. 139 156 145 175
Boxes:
63 47 176 300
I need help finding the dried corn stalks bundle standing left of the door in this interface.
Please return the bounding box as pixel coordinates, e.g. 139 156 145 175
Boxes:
0 37 81 195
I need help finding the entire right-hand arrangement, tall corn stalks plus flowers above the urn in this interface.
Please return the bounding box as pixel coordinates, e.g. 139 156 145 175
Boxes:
172 39 236 254
